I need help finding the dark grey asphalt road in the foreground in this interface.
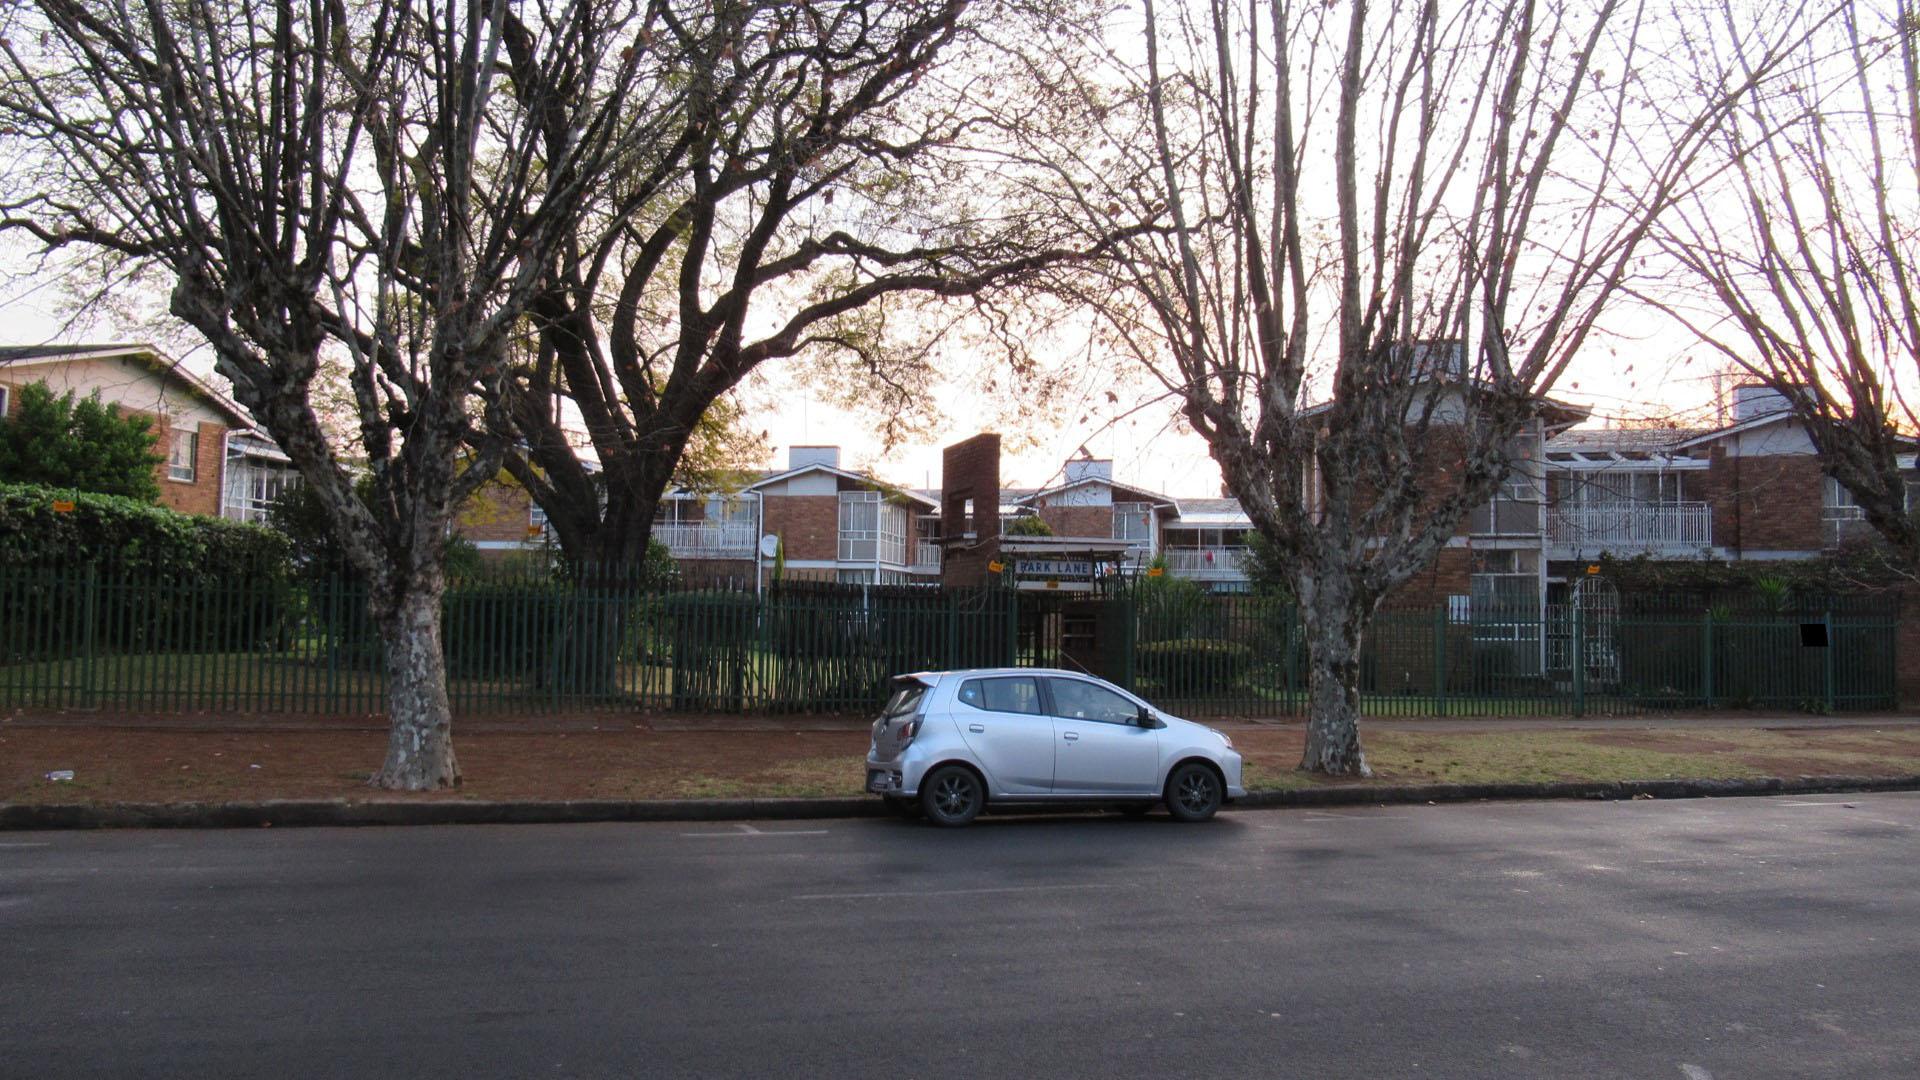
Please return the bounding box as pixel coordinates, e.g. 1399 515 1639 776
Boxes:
0 794 1920 1080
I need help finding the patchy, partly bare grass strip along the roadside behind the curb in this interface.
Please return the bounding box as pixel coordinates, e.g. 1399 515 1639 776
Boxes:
0 723 1920 803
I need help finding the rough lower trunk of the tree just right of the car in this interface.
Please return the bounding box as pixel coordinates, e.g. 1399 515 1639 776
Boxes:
1300 575 1373 776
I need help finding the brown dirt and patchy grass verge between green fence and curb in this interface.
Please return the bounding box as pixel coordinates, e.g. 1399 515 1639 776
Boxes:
0 713 1920 803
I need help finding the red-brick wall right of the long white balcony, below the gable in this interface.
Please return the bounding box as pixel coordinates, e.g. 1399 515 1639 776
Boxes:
1703 446 1826 557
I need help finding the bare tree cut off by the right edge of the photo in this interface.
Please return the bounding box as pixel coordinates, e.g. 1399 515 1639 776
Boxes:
1659 0 1920 575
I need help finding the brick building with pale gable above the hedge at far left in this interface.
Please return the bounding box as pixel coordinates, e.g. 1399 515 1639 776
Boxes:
0 344 294 521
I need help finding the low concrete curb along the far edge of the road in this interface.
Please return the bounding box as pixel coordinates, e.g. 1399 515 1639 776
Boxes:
0 774 1920 830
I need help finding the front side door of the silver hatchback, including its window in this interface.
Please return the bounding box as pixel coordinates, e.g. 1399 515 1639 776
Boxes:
1046 676 1160 796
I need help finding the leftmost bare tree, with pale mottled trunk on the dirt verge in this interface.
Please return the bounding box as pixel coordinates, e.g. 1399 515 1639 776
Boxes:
0 0 672 788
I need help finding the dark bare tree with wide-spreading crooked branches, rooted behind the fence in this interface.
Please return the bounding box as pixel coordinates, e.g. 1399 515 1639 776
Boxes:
507 0 1125 565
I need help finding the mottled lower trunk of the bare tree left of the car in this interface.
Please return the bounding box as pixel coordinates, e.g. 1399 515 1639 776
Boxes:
371 578 461 792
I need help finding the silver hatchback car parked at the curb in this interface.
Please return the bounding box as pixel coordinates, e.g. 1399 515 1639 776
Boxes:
866 667 1246 824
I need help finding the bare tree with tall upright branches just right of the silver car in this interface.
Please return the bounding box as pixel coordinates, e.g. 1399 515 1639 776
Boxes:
1036 0 1797 774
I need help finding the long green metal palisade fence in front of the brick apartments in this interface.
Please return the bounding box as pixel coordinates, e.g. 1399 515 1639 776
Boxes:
0 567 1899 717
